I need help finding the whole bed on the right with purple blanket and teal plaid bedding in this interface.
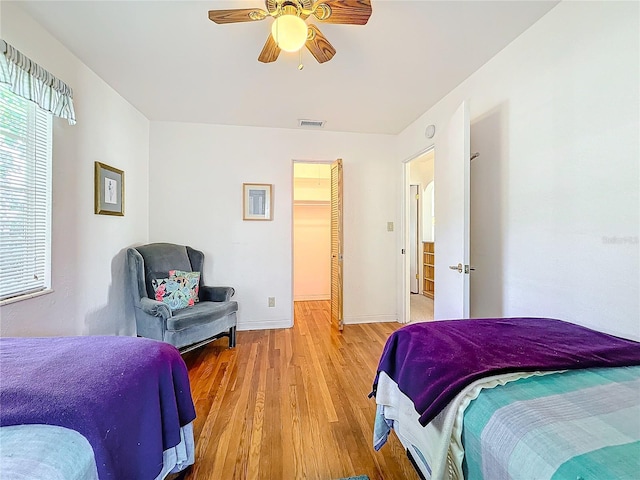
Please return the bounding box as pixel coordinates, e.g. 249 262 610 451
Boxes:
372 318 640 480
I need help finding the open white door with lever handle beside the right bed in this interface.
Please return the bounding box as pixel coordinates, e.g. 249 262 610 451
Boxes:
433 101 470 320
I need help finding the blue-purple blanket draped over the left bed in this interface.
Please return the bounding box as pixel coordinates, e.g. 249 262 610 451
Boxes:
0 337 195 480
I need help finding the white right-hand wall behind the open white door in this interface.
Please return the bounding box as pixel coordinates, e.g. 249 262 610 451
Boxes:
398 2 640 339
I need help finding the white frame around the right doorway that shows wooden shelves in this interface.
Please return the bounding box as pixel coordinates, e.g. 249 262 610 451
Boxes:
399 143 436 323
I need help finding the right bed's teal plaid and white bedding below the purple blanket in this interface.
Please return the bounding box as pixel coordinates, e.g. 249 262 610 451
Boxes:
374 366 640 480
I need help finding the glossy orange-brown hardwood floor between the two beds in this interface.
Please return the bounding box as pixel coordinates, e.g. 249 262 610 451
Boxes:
184 301 418 480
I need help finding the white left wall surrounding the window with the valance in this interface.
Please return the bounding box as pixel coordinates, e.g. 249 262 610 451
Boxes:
0 2 149 336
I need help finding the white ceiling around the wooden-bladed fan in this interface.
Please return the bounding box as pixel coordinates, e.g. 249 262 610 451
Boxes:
13 0 557 134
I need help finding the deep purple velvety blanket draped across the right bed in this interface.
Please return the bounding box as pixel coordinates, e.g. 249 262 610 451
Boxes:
373 318 640 425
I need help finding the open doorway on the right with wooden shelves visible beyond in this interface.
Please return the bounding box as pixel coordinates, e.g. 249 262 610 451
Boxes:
405 149 435 322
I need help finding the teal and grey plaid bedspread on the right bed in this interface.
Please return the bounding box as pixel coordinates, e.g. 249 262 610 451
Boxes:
462 366 640 480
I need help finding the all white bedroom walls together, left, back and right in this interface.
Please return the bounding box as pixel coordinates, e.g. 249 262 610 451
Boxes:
5 2 640 338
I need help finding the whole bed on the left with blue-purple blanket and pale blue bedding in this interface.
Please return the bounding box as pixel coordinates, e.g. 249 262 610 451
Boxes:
0 336 195 480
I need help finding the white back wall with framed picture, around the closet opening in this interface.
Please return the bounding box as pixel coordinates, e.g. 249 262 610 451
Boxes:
149 122 400 330
